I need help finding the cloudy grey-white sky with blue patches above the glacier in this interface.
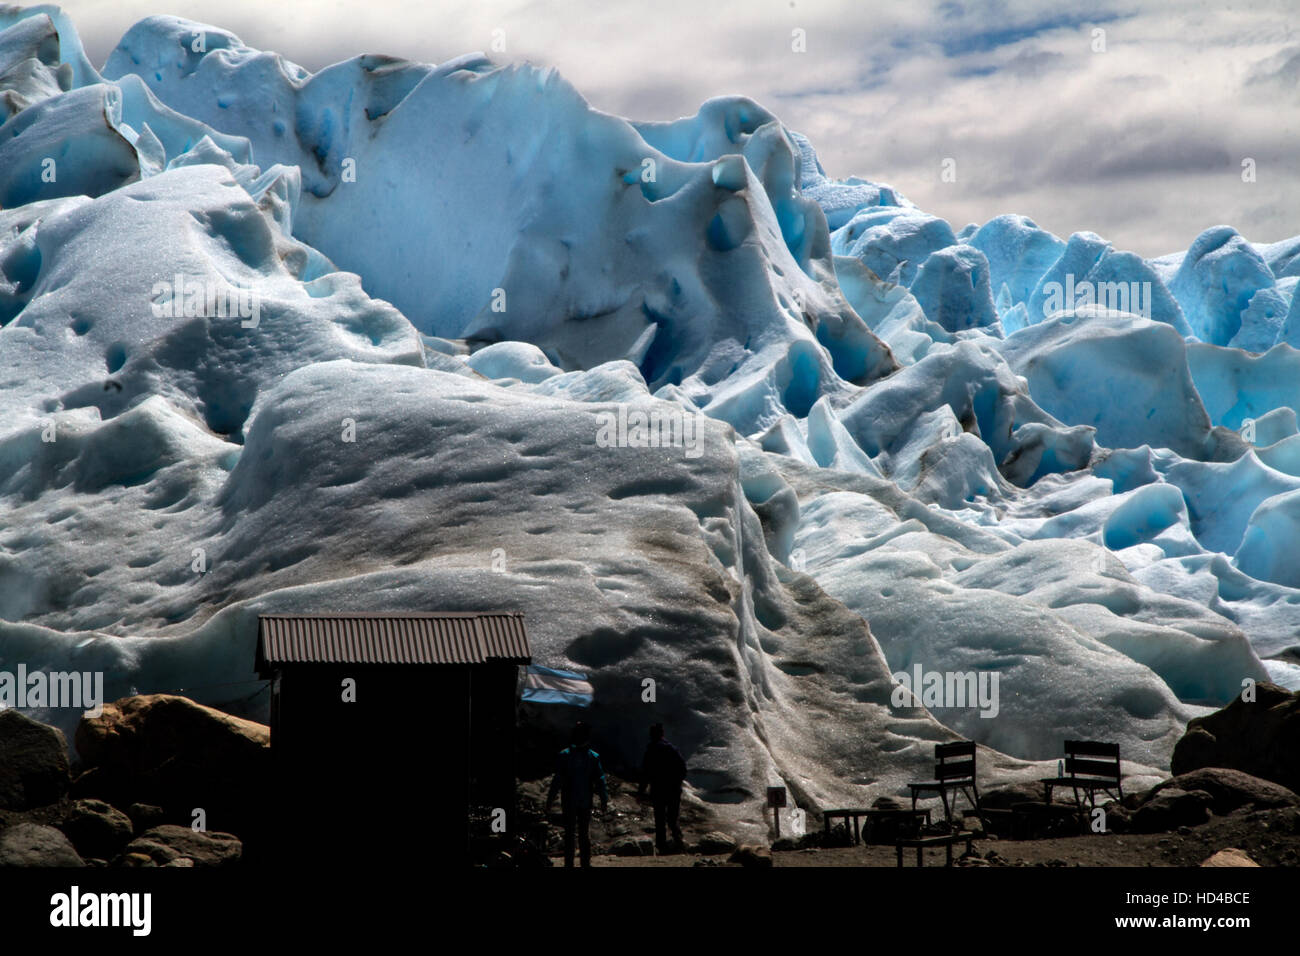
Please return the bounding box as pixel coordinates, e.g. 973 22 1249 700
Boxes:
61 0 1300 256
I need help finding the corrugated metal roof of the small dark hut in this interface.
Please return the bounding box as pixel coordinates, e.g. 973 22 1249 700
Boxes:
257 611 532 670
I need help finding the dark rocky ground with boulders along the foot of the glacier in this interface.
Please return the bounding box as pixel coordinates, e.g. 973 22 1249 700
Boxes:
0 684 1300 868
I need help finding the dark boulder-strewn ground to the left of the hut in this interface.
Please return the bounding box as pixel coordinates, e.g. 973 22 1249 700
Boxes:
0 695 263 868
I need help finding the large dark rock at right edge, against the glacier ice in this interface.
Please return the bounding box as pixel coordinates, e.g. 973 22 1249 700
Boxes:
1170 683 1300 792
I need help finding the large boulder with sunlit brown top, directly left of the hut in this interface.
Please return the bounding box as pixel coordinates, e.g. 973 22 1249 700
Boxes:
73 695 270 835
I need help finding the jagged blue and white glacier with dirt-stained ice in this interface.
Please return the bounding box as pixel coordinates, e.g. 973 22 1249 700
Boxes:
0 7 1300 832
